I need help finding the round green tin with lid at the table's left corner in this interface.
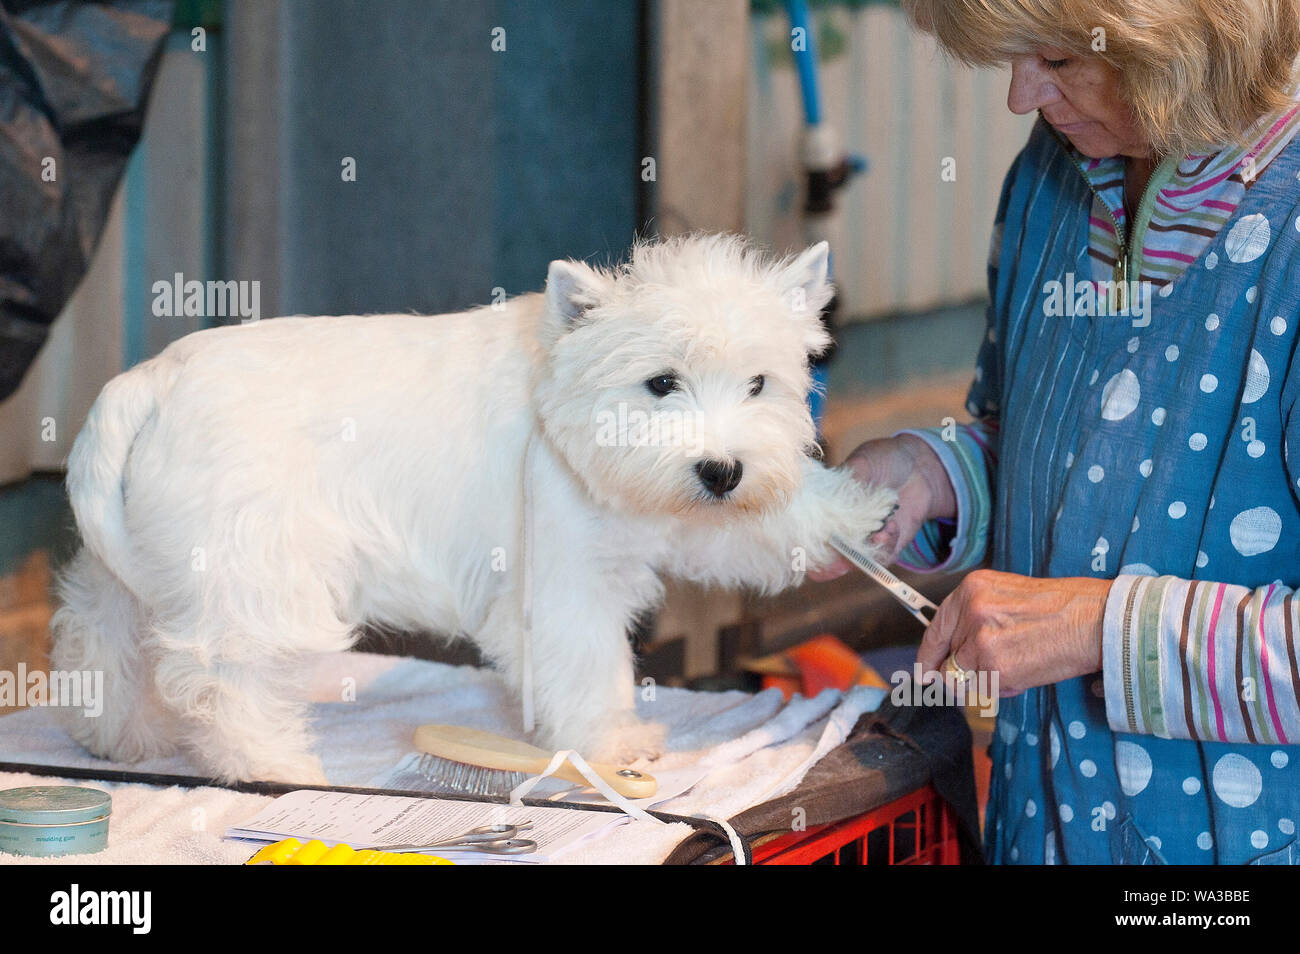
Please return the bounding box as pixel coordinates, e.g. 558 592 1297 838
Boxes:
0 785 113 858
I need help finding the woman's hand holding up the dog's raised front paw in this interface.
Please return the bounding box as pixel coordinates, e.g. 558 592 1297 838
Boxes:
809 434 957 580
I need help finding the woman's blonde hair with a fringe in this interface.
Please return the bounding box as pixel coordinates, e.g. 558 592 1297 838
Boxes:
902 0 1300 155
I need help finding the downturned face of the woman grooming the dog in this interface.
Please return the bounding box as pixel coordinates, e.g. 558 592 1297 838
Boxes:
1006 47 1152 159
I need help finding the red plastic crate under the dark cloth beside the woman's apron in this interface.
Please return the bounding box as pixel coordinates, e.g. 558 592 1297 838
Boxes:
727 785 961 864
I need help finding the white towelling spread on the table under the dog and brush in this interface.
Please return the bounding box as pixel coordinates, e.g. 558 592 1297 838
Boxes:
0 652 884 864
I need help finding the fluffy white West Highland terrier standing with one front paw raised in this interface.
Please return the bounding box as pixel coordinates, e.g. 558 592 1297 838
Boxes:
52 235 894 784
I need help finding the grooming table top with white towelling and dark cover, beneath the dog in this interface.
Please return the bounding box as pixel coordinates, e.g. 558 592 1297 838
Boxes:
0 652 975 864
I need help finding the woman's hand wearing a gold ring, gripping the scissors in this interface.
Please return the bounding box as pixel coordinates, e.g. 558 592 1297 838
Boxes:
917 569 1112 695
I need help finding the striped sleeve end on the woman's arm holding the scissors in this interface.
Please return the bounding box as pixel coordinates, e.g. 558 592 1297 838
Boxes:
1102 574 1300 745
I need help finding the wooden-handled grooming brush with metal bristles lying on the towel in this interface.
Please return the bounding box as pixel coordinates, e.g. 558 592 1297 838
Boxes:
415 725 659 798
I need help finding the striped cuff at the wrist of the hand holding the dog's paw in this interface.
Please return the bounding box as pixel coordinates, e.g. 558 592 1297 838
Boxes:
894 425 992 573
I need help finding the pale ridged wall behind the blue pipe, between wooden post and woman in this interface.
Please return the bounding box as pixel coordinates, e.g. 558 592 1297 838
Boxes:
746 6 1032 321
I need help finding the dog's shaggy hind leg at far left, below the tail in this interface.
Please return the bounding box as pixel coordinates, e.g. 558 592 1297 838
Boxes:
49 548 176 762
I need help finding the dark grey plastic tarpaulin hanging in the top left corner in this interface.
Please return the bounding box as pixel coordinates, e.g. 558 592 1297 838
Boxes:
0 0 174 400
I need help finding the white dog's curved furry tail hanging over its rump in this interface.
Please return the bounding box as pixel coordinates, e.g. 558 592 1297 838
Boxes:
68 359 179 597
